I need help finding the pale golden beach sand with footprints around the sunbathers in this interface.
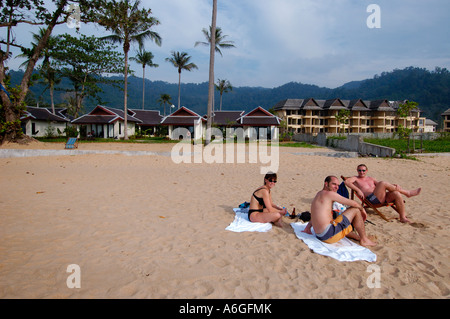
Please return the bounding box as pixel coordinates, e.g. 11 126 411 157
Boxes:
0 142 450 299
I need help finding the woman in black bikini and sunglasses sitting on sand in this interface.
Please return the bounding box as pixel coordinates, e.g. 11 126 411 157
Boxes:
248 173 286 227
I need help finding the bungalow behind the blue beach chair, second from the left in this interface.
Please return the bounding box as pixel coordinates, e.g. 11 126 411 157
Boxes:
72 105 142 138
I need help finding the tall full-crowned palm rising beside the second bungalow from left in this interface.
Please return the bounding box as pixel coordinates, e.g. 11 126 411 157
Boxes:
99 0 161 140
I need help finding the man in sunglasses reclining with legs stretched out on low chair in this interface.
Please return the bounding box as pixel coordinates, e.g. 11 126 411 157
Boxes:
345 164 421 223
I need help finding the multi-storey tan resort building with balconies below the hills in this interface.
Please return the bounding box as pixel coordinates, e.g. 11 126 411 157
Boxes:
273 98 425 134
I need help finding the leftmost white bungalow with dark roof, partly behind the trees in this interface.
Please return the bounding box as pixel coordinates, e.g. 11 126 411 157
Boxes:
20 106 70 137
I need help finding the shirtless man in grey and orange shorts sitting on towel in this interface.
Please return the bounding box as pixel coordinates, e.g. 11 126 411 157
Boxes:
304 176 376 246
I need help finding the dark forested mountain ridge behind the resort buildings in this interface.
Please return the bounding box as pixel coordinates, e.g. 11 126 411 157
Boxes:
10 67 450 123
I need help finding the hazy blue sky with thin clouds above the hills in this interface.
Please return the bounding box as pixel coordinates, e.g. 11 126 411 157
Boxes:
0 0 450 88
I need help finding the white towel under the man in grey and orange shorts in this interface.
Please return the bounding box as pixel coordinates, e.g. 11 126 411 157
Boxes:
291 222 377 262
